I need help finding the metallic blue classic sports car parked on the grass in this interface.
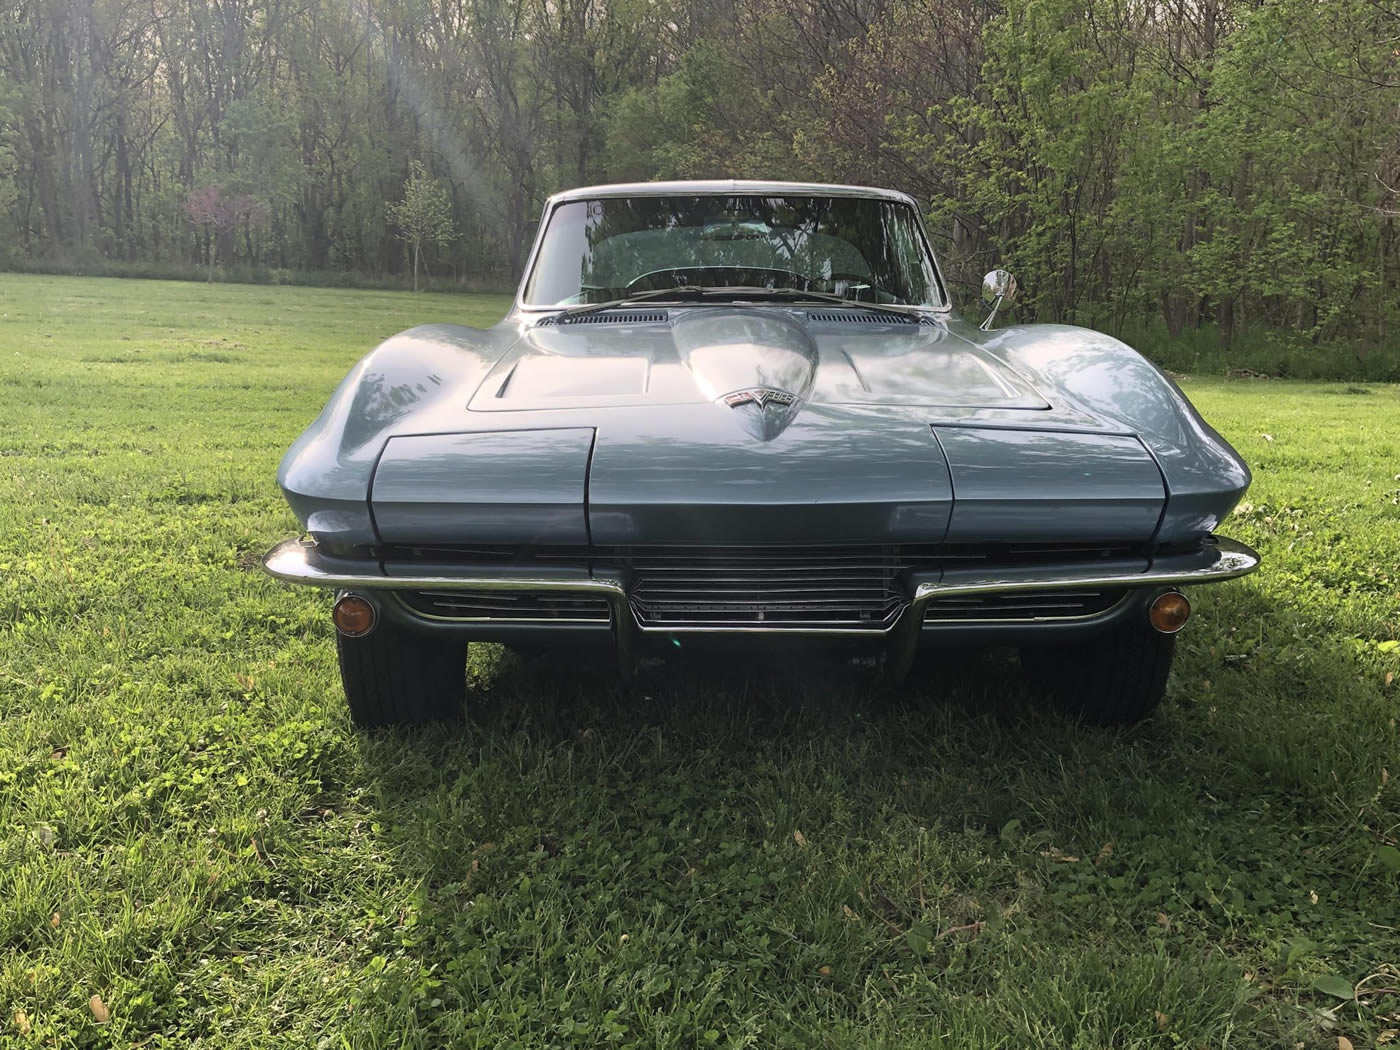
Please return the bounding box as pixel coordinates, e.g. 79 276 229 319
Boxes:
265 182 1259 725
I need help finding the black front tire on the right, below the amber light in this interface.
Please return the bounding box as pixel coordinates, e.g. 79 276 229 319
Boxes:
1021 620 1176 725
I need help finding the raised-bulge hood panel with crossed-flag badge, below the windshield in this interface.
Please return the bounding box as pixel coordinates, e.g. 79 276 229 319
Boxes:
470 307 1050 440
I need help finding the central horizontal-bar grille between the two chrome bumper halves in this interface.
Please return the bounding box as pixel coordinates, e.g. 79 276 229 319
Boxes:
623 547 907 630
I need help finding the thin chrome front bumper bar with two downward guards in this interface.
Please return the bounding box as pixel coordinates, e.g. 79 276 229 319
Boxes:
263 536 1260 666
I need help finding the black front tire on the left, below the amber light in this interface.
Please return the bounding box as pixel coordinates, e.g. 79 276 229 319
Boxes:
336 620 466 729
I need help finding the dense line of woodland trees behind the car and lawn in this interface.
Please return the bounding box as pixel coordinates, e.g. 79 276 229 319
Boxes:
0 0 1400 347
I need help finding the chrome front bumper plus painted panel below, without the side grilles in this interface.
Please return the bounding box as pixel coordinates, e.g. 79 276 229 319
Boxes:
263 536 1260 668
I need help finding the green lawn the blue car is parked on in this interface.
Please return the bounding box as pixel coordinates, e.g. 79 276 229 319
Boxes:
0 276 1400 1050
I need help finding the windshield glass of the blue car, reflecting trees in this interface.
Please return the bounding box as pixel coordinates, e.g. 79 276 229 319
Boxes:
524 196 938 307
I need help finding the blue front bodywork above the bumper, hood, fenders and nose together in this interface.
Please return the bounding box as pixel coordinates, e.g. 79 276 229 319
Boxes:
279 307 1249 545
